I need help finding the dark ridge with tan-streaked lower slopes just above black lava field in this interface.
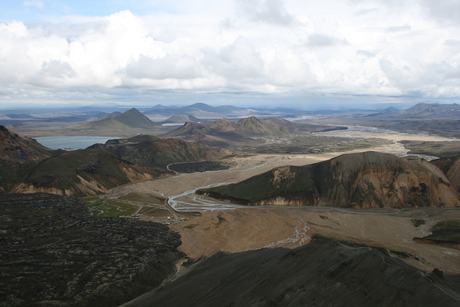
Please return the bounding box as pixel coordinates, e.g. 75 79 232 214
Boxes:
0 149 169 196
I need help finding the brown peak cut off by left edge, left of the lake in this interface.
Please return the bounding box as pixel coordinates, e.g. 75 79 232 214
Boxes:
0 125 53 161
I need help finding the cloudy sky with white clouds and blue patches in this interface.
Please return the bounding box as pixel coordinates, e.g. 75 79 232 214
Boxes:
0 0 460 107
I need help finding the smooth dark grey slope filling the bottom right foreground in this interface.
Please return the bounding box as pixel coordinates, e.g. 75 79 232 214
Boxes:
123 238 460 307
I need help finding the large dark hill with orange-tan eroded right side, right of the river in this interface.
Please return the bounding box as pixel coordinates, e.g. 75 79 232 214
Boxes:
197 152 460 208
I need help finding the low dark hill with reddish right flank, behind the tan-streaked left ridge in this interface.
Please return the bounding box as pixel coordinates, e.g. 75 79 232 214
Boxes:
89 135 231 165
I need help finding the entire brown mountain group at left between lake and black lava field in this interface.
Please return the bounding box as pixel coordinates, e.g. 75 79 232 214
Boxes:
0 126 230 196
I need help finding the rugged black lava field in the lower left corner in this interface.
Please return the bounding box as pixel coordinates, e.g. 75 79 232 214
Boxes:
0 194 182 306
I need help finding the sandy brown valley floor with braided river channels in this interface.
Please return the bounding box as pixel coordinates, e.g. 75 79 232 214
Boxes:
99 131 460 274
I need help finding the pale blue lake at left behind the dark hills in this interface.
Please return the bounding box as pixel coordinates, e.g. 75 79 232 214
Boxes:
35 136 119 150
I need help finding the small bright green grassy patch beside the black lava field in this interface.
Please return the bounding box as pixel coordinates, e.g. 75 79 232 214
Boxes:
85 198 138 217
